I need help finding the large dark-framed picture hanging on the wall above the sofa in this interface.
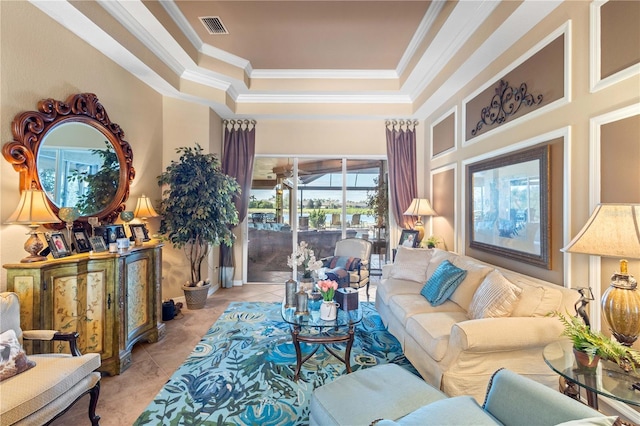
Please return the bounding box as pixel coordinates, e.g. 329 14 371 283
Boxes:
467 145 551 269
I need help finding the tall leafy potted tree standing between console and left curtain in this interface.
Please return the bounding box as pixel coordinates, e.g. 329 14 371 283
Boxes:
158 144 240 309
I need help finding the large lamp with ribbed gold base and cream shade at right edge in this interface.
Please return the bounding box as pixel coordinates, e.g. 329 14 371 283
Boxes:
562 204 640 346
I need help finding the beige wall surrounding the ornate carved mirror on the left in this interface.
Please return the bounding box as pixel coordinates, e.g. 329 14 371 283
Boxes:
0 2 162 289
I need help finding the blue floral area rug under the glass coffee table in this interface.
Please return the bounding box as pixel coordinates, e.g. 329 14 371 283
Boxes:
135 302 417 425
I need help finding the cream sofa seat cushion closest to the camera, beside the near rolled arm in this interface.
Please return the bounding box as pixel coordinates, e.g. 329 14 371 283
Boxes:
405 312 467 361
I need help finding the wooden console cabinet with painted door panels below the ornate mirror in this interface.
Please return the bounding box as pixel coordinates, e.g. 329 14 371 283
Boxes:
3 241 165 375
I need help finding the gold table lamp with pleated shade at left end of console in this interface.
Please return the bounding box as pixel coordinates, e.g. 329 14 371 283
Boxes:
6 186 61 263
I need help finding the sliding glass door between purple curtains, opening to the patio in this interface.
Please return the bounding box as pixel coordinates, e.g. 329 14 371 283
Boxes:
246 157 386 283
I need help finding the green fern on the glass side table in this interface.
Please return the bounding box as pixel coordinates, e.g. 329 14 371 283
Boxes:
553 312 640 372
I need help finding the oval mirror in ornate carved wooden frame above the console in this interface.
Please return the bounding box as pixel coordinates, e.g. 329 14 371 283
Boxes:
2 93 135 223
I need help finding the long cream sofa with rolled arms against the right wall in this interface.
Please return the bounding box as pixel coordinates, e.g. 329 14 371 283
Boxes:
376 247 579 403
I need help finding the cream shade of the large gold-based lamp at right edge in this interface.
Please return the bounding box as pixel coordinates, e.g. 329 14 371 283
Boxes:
562 204 640 259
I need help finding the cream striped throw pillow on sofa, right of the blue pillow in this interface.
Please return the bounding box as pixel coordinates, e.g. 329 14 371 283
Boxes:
469 270 522 319
